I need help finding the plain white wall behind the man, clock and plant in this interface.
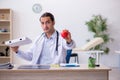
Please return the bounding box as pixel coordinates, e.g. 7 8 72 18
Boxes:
0 0 120 67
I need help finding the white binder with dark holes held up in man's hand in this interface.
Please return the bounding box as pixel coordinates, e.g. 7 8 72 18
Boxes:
5 37 32 47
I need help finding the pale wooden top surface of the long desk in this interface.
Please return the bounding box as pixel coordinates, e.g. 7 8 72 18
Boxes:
0 64 111 72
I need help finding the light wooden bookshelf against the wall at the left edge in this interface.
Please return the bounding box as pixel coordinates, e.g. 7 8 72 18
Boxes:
0 9 12 63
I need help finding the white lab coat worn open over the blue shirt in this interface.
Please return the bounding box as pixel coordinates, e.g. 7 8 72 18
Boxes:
17 31 75 64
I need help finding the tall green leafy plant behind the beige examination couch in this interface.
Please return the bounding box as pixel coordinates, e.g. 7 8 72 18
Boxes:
86 15 112 53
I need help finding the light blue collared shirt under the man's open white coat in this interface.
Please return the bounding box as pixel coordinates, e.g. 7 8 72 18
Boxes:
37 32 57 64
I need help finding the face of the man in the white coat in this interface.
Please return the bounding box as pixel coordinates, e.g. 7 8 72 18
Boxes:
40 17 55 33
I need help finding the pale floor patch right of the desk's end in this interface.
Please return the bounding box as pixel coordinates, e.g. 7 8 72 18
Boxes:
109 68 120 80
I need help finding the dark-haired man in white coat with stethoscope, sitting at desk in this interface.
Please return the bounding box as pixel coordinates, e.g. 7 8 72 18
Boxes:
11 12 75 64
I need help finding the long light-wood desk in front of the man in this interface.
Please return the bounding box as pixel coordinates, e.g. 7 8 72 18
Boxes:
0 64 111 80
